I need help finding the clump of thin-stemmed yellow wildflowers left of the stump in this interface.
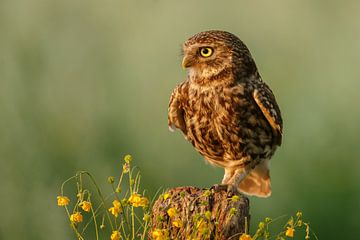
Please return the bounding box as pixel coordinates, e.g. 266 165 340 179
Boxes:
57 155 150 240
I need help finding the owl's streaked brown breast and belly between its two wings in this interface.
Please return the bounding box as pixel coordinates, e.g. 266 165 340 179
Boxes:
185 82 274 165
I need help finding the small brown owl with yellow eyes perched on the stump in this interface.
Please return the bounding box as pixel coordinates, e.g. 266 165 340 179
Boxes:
168 31 283 197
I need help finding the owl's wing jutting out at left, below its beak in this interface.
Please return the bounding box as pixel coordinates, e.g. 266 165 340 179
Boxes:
168 82 187 135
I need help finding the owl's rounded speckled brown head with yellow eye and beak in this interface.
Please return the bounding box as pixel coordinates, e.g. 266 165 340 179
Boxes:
182 30 257 82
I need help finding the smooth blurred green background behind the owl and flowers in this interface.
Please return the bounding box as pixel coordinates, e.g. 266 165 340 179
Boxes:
0 0 360 239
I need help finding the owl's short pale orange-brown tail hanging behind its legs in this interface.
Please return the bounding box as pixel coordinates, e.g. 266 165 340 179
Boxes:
239 160 271 198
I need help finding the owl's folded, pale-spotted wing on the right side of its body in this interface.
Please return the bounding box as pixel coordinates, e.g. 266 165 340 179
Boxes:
252 82 283 146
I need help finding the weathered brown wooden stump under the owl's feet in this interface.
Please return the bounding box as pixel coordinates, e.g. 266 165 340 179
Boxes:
149 187 250 240
